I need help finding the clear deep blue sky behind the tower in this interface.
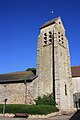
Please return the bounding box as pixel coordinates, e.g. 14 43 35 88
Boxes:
0 0 80 74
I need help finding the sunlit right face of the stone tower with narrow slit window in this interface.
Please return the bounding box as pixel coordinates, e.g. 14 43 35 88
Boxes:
55 19 73 111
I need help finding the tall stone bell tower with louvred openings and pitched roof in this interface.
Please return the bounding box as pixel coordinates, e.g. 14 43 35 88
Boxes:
37 17 73 111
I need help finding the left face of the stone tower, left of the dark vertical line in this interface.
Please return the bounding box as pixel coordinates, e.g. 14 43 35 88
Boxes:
37 25 53 96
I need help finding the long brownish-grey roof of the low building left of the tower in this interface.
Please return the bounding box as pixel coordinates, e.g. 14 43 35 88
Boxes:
0 71 36 83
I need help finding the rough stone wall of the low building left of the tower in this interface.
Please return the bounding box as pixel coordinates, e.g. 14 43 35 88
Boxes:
0 83 33 104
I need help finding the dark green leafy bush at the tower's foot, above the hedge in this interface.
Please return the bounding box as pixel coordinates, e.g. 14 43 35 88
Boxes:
35 95 56 106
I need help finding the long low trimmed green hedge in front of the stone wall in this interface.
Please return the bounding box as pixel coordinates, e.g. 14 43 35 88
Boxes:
0 104 59 115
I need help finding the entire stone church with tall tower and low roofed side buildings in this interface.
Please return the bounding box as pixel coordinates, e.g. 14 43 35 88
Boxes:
0 17 80 111
